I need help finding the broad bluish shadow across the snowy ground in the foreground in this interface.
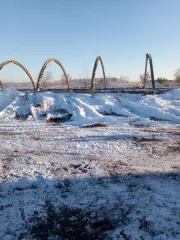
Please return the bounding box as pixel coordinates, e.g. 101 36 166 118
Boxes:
0 172 180 240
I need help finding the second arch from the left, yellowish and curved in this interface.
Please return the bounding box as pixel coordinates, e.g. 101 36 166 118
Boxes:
36 58 70 91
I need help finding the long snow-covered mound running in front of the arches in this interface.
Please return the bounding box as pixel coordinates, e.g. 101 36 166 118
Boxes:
0 89 180 126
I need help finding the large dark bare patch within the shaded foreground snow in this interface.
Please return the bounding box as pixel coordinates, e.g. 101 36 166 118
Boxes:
30 201 115 240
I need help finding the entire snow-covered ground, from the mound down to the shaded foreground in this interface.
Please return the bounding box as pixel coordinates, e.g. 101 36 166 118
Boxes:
0 89 180 240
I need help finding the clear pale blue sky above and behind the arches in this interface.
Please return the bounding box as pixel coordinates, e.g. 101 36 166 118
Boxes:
0 0 180 81
